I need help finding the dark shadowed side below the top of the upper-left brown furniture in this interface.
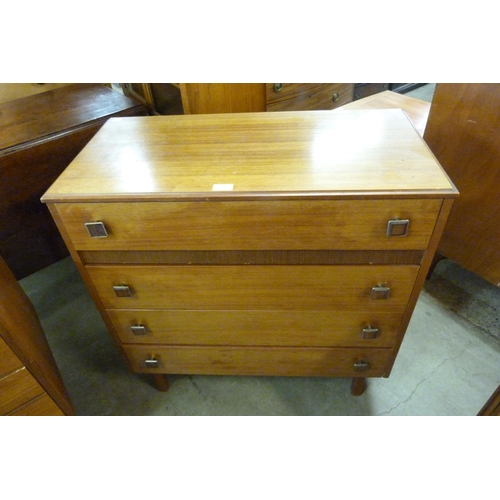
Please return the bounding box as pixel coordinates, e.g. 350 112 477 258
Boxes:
0 126 99 279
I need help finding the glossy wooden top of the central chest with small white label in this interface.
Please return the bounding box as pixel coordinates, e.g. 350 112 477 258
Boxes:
42 110 457 202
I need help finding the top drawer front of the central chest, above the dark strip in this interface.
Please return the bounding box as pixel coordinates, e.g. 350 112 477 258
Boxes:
53 199 441 251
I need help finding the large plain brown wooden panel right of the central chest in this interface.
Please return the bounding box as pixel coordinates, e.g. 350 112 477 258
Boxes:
424 83 500 286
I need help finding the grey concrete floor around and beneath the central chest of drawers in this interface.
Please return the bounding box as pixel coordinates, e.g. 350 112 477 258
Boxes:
17 84 500 416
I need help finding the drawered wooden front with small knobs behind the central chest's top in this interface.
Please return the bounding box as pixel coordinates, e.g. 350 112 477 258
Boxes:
266 83 354 111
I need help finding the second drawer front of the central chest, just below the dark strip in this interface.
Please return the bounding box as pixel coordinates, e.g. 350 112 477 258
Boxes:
87 265 419 311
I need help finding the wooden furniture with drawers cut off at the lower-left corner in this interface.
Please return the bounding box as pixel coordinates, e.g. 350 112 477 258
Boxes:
0 257 74 416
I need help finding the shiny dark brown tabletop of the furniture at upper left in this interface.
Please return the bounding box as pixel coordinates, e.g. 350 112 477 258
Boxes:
0 83 145 156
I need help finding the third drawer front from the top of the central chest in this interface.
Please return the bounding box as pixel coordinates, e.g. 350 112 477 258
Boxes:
107 306 404 347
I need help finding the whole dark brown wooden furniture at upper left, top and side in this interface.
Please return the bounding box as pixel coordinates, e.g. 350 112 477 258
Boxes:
0 84 147 279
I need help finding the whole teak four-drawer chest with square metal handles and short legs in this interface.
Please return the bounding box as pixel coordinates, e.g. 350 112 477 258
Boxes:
42 110 458 394
